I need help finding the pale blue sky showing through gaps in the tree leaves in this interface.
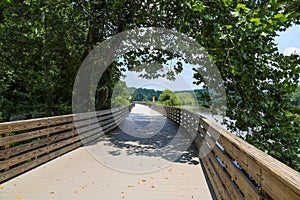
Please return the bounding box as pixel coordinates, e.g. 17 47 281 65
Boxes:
124 25 300 91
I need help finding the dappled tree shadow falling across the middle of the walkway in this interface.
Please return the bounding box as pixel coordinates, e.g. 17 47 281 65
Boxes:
91 110 199 165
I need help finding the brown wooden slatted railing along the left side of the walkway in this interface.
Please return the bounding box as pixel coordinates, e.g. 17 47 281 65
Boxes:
0 104 134 182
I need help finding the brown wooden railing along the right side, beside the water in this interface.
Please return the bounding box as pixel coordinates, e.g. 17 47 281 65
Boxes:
137 102 300 200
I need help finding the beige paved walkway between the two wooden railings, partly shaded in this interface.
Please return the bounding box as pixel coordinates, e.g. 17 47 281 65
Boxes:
0 105 211 200
